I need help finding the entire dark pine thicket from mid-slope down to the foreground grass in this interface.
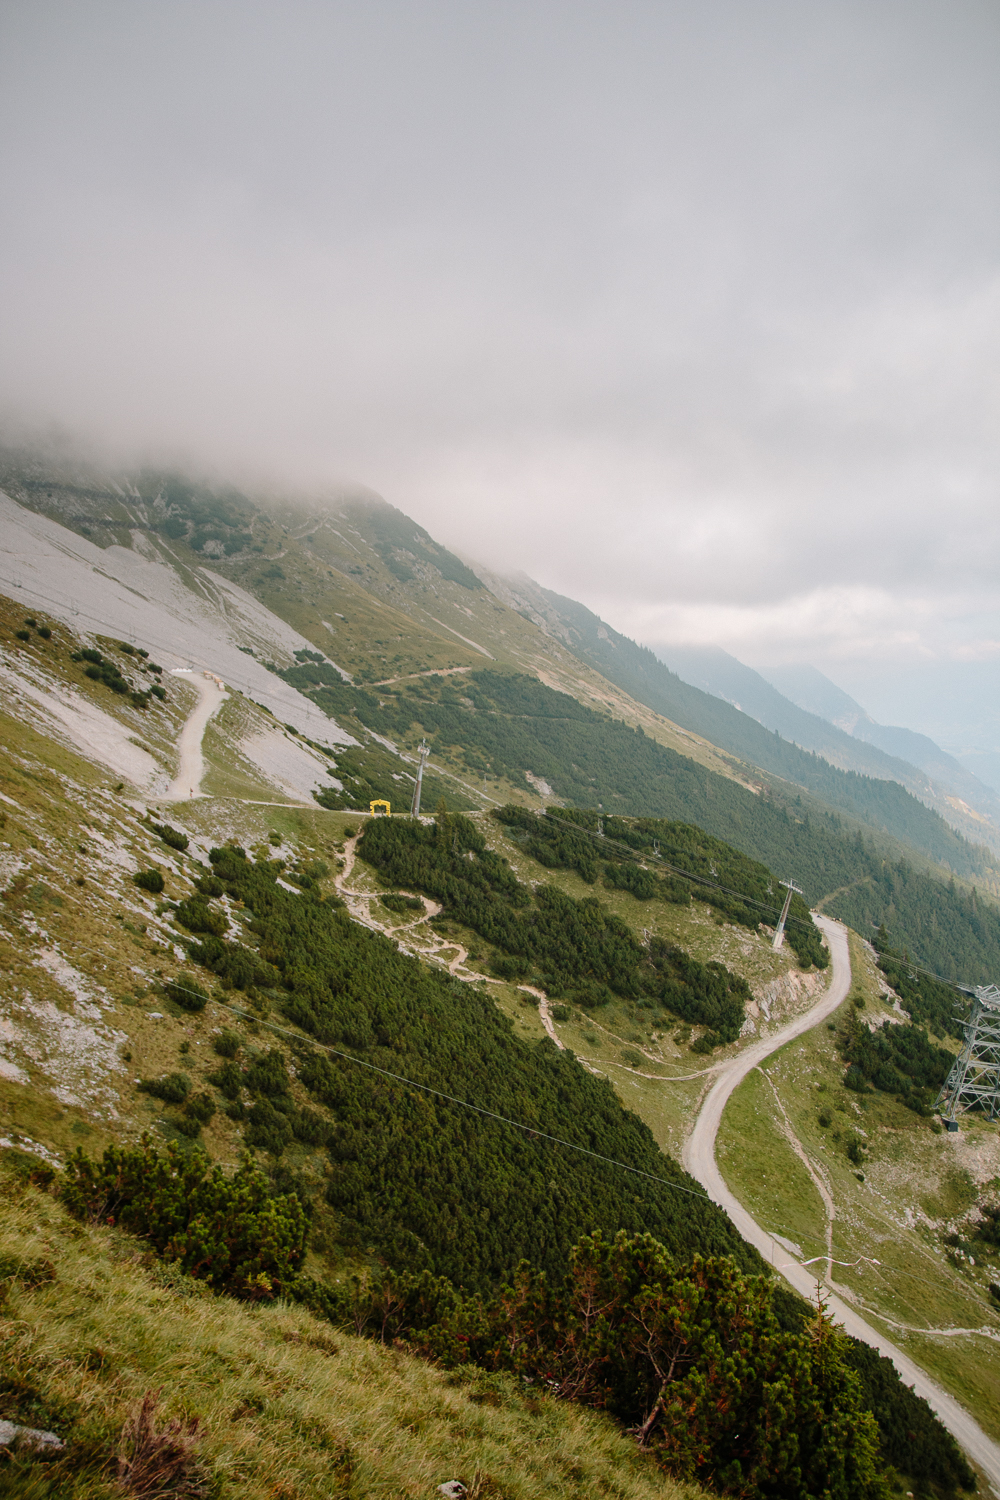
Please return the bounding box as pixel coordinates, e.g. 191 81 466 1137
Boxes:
46 818 972 1500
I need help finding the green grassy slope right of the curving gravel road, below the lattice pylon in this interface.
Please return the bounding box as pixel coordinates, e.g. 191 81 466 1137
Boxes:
718 936 1000 1437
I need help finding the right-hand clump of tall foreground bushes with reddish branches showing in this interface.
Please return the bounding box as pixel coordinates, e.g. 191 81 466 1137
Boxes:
316 1235 888 1500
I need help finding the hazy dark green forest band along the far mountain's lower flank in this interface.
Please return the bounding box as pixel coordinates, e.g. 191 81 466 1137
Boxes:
282 662 1000 983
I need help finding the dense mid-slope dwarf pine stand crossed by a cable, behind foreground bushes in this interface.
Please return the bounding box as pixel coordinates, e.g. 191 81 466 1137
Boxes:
182 846 757 1290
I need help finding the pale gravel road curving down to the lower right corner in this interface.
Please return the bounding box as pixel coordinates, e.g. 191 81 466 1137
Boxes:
684 917 1000 1497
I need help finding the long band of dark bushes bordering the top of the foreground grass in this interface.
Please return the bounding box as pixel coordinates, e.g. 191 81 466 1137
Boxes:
50 1139 975 1500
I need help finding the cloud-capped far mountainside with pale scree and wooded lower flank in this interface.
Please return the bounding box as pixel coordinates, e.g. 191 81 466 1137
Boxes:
0 444 1000 974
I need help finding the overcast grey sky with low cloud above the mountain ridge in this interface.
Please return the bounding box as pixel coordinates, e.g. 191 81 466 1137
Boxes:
0 0 1000 749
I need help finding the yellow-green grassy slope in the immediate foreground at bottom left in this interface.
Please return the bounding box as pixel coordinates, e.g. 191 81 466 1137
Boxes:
0 1172 693 1500
